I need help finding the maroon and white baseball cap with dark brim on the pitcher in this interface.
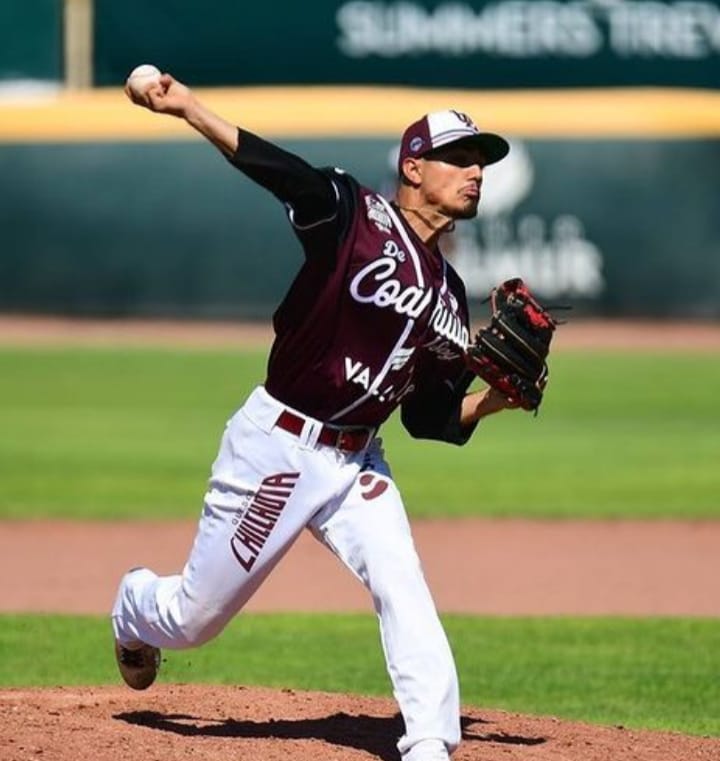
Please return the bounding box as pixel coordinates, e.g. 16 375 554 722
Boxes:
398 110 510 177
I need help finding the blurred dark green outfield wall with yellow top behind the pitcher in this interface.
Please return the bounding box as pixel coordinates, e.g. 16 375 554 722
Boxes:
0 88 720 319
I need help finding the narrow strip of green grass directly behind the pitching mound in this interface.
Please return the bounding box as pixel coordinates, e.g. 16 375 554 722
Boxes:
0 614 720 736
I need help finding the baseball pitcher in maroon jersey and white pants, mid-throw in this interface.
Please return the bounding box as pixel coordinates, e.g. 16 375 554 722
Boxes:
112 74 546 761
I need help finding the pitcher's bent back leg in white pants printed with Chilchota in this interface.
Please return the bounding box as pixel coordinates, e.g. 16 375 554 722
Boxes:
113 398 335 648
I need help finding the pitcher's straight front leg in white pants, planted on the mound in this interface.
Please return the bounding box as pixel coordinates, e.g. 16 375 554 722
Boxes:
312 446 460 754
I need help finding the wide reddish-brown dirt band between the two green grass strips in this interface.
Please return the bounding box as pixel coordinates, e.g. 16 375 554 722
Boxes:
0 519 720 617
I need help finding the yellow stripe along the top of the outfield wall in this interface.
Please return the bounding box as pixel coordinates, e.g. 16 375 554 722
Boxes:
0 86 720 143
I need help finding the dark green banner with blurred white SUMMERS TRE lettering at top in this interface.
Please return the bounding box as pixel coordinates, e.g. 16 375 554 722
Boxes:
94 0 720 89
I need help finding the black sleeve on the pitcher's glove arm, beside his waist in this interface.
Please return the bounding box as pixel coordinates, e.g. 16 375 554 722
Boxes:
400 361 477 446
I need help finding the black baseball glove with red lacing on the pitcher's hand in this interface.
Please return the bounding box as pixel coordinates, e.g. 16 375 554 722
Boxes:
465 278 559 413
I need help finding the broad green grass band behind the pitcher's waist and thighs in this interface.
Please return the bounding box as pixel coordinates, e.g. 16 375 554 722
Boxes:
0 348 720 519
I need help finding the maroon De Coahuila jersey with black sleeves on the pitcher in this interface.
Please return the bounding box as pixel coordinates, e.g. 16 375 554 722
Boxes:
233 129 472 443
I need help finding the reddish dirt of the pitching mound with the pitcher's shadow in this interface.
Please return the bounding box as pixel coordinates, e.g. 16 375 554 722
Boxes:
0 685 720 761
